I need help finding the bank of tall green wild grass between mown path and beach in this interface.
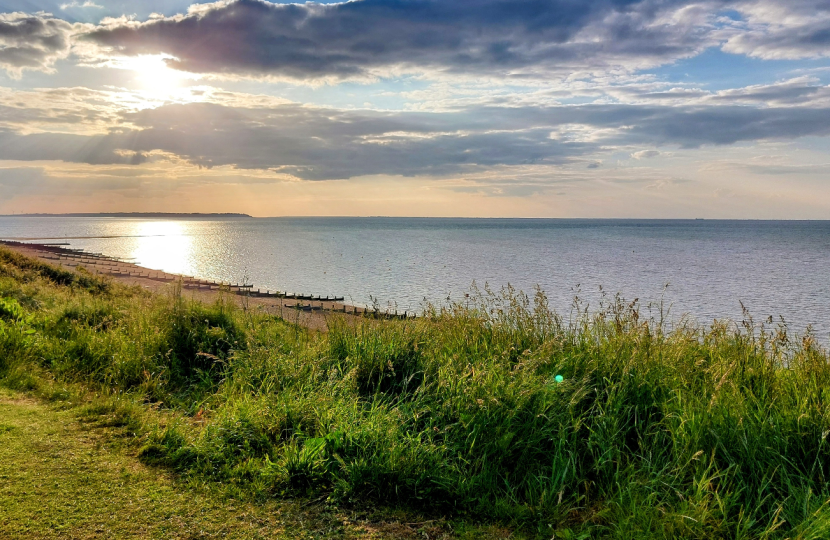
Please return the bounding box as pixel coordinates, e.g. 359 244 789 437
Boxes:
0 246 830 538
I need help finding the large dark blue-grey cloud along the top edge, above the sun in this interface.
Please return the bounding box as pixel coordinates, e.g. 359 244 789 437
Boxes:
85 0 718 79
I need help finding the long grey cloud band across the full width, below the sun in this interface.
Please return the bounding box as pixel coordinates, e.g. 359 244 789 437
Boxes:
0 99 830 180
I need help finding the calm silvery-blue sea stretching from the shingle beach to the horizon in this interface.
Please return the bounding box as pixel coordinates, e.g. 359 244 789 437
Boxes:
0 217 830 341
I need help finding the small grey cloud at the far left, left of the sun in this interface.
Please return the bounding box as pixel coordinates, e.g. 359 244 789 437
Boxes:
0 13 74 77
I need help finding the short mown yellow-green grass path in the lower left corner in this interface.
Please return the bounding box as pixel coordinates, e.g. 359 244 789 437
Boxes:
0 389 414 540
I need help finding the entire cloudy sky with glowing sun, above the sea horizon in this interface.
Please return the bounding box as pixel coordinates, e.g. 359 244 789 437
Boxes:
0 0 830 219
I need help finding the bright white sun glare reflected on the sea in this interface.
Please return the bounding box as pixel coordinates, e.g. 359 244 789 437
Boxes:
131 221 193 274
